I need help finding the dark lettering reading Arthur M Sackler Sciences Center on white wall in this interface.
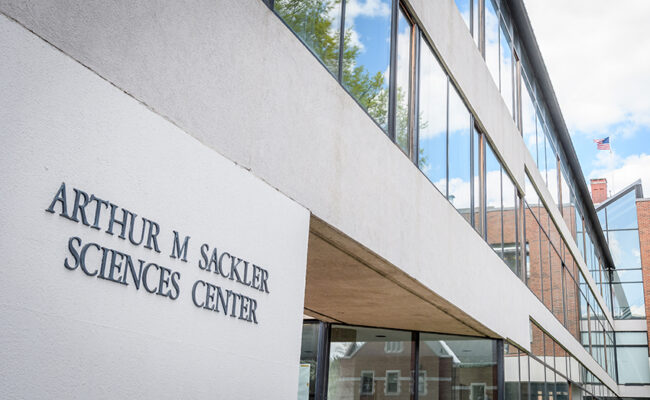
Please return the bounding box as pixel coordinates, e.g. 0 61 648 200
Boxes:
45 182 270 324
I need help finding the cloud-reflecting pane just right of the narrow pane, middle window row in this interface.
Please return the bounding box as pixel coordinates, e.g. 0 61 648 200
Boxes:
418 39 447 192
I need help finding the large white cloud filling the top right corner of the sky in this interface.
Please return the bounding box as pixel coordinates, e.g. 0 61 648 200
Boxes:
525 0 650 135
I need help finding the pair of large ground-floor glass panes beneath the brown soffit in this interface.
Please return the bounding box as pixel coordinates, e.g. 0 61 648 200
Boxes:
318 325 500 400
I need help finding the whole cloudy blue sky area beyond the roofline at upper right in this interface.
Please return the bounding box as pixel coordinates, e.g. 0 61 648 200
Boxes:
525 0 650 197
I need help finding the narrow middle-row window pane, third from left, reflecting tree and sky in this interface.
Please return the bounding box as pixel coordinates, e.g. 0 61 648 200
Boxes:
395 8 413 154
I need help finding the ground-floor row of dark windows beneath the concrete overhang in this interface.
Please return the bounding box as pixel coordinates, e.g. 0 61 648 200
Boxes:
299 320 614 400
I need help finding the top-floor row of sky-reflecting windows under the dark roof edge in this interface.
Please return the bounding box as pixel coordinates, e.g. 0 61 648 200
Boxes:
455 0 612 309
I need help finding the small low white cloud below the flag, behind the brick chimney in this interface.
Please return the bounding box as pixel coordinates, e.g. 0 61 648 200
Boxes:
589 151 650 197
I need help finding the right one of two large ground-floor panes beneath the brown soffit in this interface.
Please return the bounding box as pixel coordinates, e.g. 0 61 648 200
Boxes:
419 333 497 400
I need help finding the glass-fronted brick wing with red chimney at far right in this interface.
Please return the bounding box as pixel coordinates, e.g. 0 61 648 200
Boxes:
591 179 650 385
